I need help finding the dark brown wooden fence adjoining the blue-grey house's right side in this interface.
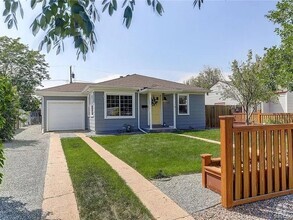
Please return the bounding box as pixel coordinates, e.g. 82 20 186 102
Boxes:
205 105 241 128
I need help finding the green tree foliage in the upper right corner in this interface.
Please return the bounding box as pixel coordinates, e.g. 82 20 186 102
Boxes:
264 0 293 90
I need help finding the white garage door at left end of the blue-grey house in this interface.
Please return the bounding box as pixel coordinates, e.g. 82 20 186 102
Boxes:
47 101 85 131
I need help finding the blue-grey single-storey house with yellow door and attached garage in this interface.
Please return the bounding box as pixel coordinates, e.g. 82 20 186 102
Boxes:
37 74 207 133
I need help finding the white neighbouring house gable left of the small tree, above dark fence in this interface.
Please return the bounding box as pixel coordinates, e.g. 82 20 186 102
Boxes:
205 81 238 106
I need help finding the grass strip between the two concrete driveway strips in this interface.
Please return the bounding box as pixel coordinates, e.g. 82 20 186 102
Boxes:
62 138 152 220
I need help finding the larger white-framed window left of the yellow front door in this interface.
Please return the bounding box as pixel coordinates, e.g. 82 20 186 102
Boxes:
105 94 134 118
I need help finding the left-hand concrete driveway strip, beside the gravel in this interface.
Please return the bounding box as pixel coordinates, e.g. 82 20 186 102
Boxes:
42 133 79 220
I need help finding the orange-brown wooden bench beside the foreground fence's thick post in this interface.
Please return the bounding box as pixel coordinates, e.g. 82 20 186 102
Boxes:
201 154 221 195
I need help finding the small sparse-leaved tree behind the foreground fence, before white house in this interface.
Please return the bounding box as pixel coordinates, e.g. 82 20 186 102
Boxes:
222 51 276 125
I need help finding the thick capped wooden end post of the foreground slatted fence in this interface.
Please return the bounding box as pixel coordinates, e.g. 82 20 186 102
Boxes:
220 116 234 208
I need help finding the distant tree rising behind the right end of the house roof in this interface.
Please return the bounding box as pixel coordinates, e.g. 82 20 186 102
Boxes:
184 67 223 89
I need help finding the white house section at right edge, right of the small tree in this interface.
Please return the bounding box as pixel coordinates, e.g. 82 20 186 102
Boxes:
261 91 293 113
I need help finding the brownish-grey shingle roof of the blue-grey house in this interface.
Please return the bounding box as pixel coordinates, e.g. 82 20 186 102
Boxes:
37 74 207 92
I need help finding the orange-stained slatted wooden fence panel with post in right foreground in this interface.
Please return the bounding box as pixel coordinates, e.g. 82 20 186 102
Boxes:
220 116 293 208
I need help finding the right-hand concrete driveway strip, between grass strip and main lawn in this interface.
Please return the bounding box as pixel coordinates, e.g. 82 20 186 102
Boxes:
77 133 194 220
